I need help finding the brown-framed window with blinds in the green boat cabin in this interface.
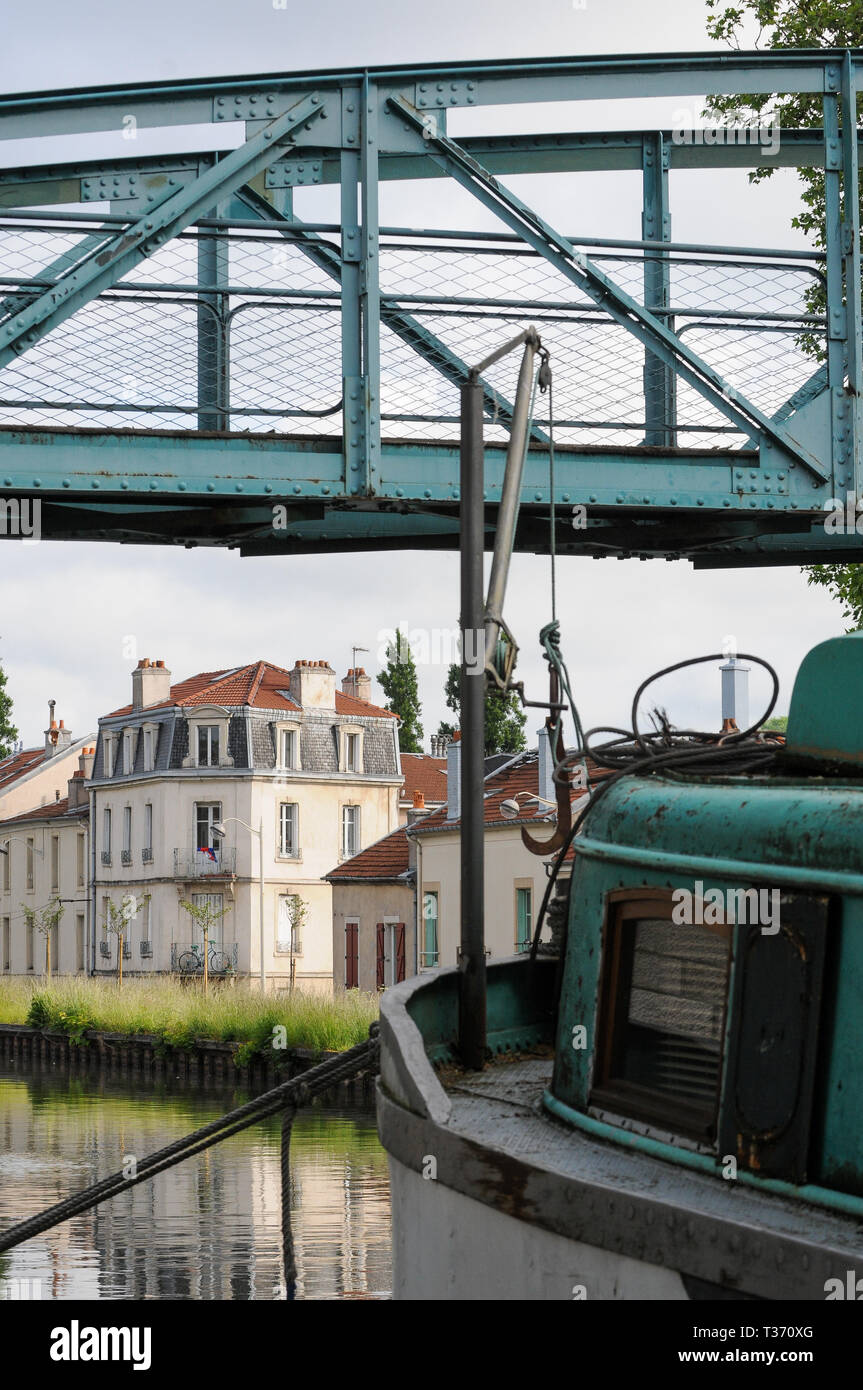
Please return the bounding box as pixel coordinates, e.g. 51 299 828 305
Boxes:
591 890 731 1143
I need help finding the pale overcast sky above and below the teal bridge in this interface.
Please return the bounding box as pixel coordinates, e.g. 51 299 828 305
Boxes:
0 0 844 744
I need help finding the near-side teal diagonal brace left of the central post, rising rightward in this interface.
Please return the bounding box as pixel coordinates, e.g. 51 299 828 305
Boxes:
0 92 324 367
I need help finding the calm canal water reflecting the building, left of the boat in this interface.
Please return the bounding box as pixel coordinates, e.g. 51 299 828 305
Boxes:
0 1068 391 1300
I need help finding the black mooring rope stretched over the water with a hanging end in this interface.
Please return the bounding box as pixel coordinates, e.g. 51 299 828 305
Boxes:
0 1023 381 1298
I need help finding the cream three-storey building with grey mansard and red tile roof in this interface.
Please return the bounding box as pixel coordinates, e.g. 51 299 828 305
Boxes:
90 660 402 991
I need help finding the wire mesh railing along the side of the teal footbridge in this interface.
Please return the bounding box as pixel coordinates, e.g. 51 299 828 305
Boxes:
0 214 824 448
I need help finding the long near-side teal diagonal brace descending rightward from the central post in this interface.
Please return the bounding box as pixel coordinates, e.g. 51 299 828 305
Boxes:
389 96 830 482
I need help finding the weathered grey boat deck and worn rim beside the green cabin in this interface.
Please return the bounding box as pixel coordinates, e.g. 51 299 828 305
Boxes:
408 1048 863 1298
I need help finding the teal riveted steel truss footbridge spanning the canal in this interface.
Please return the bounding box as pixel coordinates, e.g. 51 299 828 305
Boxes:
0 50 863 566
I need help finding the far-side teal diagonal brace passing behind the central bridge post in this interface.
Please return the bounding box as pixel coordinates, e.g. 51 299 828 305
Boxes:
238 188 548 443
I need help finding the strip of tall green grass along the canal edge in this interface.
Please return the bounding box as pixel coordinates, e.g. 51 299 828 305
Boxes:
0 977 378 1061
